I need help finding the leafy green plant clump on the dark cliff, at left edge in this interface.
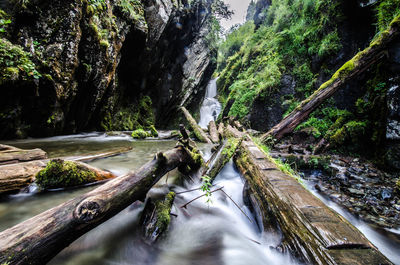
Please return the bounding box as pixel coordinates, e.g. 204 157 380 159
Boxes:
0 38 41 84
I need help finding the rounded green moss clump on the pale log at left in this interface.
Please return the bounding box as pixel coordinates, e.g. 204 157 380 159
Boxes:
36 159 96 189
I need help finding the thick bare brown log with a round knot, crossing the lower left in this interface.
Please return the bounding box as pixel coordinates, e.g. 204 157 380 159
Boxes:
0 146 193 264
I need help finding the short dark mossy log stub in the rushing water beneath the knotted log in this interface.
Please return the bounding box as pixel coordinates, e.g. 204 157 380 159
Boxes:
141 191 175 243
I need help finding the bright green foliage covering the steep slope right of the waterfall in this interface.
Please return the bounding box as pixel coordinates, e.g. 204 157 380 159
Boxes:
218 0 341 121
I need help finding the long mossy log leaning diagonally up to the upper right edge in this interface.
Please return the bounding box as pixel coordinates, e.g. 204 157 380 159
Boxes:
262 16 400 141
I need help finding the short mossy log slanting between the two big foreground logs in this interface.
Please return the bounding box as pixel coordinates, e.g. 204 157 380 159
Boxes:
205 138 242 181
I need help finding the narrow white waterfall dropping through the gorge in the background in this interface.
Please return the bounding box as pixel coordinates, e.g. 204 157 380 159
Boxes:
199 79 221 129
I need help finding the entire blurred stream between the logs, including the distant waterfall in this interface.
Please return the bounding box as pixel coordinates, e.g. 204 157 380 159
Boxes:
0 80 400 265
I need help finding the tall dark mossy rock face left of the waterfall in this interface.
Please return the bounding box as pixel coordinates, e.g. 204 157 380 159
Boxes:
0 0 213 138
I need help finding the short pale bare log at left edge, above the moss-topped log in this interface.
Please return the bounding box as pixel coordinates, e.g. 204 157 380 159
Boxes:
0 144 47 165
